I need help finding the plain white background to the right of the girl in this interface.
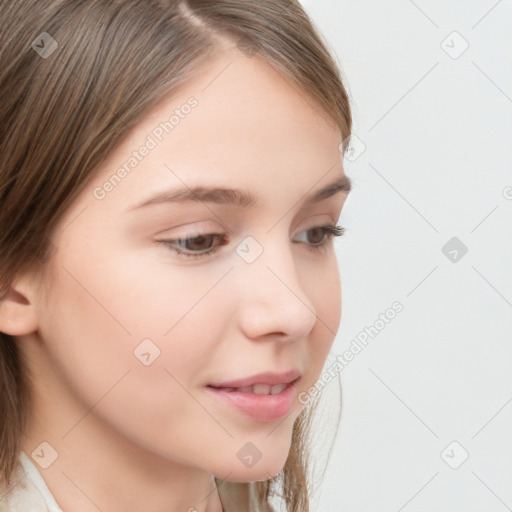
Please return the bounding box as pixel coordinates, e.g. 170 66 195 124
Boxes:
296 0 512 512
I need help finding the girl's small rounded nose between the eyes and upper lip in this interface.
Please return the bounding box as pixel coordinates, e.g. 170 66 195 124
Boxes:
237 237 317 341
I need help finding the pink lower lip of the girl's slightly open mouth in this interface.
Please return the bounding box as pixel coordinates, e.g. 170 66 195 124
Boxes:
206 381 297 421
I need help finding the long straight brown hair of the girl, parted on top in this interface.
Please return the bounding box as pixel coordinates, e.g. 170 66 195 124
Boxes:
0 0 352 512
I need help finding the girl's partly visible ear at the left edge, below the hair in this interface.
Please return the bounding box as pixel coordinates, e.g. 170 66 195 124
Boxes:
0 274 39 336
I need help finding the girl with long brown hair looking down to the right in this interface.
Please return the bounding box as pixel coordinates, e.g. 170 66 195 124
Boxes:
0 0 351 512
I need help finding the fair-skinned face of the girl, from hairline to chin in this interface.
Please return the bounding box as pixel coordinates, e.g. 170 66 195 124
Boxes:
26 47 347 481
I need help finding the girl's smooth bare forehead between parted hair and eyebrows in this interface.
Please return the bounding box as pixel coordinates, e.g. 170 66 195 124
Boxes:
81 51 342 216
